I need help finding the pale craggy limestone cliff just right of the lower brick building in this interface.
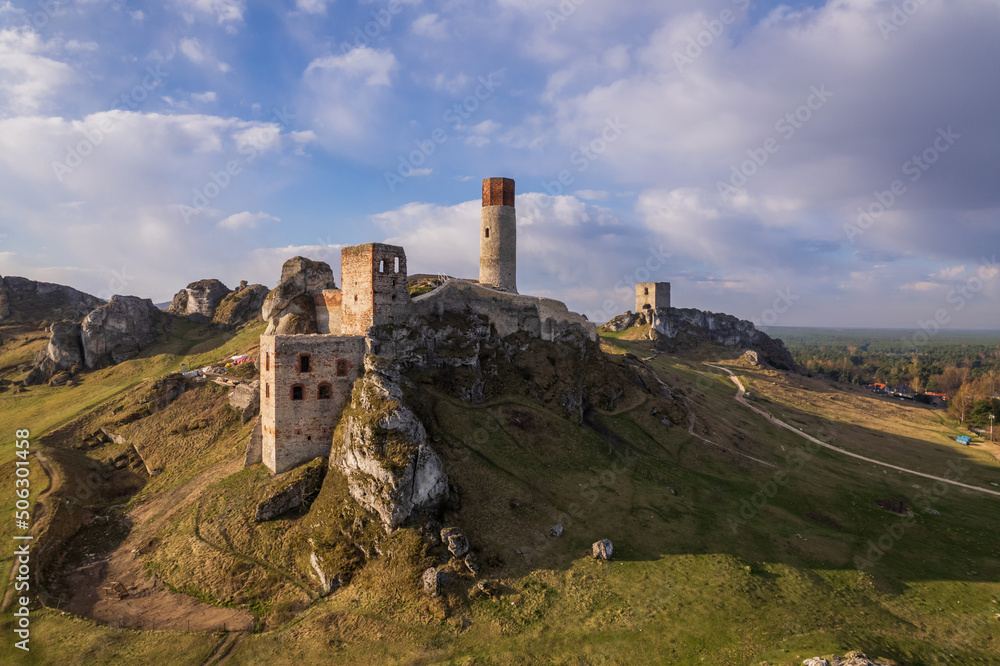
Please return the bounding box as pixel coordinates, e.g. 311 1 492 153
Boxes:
330 355 448 531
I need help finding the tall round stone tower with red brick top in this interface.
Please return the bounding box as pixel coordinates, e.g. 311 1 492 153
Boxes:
479 178 517 294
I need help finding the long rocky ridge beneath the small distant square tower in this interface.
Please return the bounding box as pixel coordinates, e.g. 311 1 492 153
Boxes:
603 308 797 370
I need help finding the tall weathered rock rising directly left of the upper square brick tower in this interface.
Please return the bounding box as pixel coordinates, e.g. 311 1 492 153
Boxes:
261 257 336 335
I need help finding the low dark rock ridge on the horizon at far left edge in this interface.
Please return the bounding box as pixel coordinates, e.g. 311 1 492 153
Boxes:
0 275 104 322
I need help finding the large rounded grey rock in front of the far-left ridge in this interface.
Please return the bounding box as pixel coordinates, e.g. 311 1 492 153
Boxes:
80 296 167 368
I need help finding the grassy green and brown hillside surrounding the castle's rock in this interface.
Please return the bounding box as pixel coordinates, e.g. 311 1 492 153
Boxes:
0 325 1000 665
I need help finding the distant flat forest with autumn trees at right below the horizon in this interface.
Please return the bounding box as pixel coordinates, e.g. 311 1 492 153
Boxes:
763 327 1000 428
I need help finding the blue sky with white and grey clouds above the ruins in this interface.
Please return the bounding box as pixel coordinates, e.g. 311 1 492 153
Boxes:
0 0 1000 329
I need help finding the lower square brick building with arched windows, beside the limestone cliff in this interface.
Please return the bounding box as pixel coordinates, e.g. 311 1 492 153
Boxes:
260 335 365 474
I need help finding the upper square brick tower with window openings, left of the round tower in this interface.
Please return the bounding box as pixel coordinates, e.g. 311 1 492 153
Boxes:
340 243 410 335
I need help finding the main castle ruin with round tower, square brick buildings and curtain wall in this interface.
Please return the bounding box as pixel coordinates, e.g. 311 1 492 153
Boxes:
259 178 597 474
